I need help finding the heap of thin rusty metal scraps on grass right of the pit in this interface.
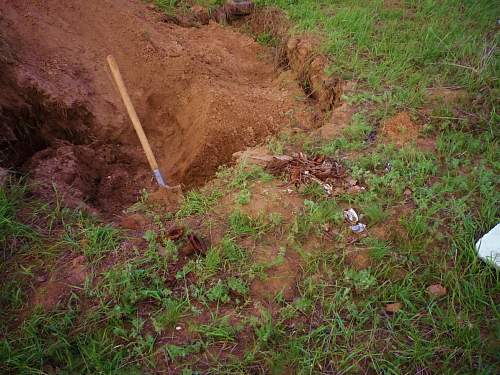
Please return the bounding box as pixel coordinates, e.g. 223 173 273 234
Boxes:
266 152 345 195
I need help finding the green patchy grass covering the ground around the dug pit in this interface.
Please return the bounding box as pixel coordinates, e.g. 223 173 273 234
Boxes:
0 0 500 374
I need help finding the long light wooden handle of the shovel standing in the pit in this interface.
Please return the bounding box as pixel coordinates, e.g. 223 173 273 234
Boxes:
107 55 158 172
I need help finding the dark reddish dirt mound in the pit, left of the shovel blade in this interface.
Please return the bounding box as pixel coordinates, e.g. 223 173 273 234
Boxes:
24 143 154 213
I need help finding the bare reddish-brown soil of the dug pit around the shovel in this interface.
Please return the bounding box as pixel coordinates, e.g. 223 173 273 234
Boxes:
0 0 312 211
